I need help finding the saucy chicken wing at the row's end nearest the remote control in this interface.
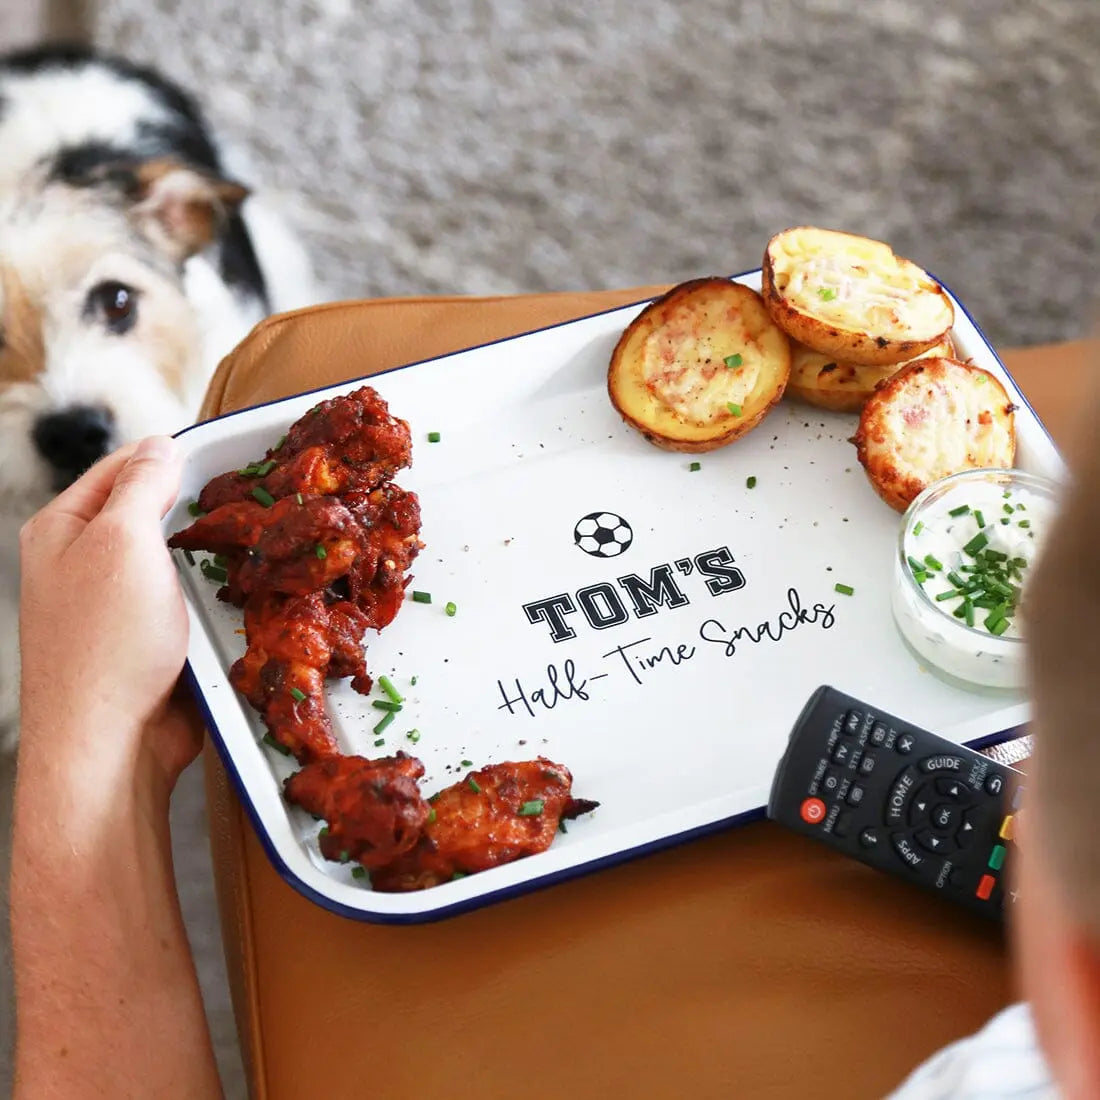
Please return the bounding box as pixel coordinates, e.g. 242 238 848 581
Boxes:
371 757 598 893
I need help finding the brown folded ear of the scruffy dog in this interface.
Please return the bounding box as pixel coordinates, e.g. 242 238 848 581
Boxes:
127 157 249 262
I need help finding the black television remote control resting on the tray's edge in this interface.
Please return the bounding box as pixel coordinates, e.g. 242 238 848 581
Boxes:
768 688 1023 919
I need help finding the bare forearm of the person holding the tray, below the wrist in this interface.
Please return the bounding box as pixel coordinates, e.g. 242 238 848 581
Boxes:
11 729 221 1100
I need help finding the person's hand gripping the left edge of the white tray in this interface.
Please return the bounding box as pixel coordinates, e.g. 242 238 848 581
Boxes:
20 437 201 793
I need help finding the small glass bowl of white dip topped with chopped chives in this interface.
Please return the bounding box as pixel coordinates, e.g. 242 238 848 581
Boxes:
891 470 1058 691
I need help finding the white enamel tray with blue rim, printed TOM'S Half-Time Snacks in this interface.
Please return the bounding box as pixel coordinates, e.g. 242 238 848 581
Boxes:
165 272 1063 923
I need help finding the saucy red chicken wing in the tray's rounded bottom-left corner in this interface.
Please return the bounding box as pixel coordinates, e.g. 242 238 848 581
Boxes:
283 752 431 871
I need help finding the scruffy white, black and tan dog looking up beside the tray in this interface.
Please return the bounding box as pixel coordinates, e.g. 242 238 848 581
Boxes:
0 47 316 751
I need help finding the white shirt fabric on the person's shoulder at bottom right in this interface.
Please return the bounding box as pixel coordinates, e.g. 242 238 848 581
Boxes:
889 1004 1062 1100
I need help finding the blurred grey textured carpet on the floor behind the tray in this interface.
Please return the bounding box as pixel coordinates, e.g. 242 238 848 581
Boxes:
4 0 1100 1096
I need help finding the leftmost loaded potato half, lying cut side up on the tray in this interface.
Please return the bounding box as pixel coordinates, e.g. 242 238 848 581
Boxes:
607 277 791 453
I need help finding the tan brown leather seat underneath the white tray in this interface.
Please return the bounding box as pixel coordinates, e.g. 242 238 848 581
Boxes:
205 288 1085 1100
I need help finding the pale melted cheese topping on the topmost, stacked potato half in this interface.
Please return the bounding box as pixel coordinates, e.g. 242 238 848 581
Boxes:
769 229 954 340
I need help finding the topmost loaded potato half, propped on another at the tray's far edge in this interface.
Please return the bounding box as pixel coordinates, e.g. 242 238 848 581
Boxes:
761 226 955 366
